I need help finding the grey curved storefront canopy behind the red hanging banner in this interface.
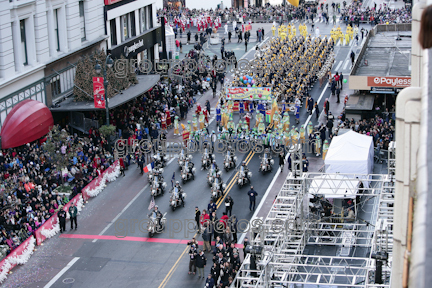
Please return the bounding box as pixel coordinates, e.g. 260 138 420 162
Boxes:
50 75 160 112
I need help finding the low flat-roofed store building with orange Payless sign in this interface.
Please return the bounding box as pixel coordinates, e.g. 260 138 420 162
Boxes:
345 24 412 120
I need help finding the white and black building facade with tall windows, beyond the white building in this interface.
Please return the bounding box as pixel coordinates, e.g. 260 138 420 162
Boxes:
105 0 162 63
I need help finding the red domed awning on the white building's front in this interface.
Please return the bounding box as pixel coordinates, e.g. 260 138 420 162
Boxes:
0 99 54 149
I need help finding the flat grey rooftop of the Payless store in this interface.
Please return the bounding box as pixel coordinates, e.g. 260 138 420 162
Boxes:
353 31 412 76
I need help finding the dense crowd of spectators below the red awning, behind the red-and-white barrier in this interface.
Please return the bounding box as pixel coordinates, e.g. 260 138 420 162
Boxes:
0 126 113 254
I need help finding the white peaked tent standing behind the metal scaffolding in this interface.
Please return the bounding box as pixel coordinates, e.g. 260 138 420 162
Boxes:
325 131 374 174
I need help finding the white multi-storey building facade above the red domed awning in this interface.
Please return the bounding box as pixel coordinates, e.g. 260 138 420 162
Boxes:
0 0 106 127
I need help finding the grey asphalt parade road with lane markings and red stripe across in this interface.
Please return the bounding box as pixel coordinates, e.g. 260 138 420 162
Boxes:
3 10 372 287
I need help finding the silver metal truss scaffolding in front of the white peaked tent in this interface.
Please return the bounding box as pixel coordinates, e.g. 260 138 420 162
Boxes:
231 173 395 288
